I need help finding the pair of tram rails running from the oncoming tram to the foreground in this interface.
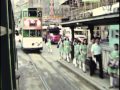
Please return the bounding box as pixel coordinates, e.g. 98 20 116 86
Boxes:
28 54 80 90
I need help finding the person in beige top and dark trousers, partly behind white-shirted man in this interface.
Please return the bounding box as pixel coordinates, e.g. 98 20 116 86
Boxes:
87 38 96 76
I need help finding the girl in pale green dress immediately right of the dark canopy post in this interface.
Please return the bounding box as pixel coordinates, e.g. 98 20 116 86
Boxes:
73 41 79 67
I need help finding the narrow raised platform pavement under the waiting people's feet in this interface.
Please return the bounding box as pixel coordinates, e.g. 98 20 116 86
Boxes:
58 60 119 90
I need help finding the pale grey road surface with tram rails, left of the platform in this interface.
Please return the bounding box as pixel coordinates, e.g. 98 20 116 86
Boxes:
16 42 96 90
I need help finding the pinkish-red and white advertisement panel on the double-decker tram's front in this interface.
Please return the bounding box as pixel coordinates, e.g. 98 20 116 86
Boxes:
23 18 42 30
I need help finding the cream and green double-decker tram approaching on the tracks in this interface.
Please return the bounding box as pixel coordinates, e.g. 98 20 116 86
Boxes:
20 8 43 50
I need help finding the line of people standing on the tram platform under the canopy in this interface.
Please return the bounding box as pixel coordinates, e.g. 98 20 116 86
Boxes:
58 37 119 88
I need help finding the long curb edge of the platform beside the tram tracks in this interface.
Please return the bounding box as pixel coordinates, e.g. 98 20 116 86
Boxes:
57 60 109 90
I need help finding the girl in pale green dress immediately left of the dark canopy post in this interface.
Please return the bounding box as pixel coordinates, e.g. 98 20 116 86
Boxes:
64 38 71 62
